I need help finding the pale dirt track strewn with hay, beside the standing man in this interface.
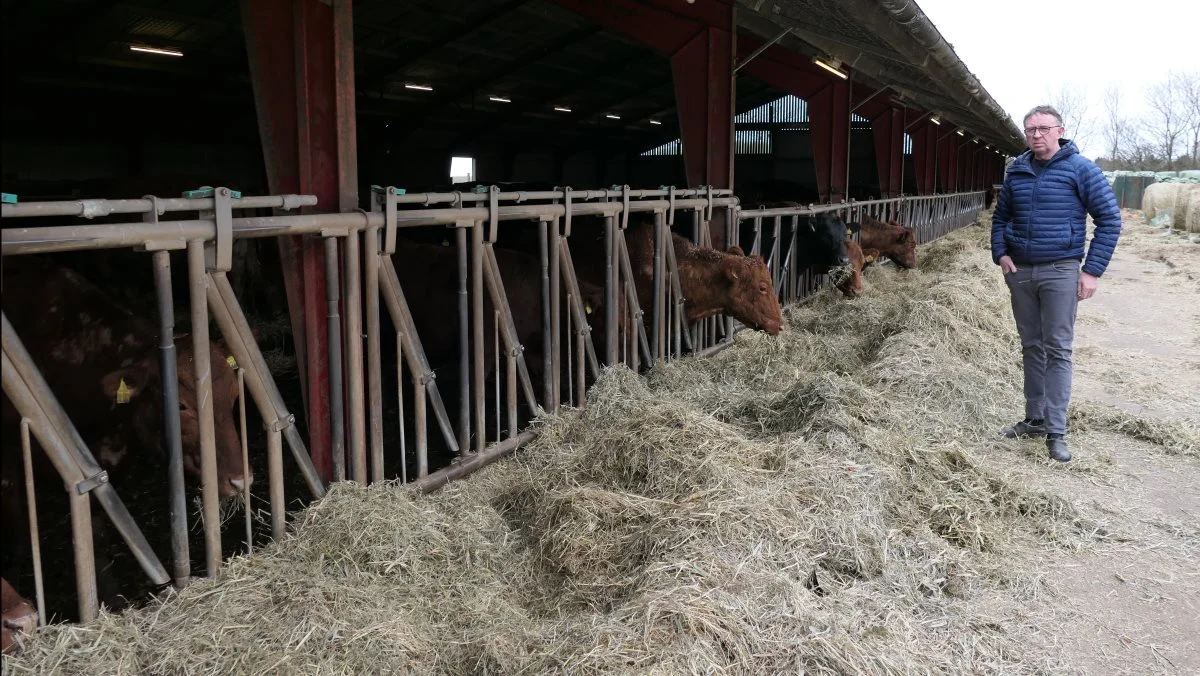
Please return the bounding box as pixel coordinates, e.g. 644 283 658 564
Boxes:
988 211 1200 675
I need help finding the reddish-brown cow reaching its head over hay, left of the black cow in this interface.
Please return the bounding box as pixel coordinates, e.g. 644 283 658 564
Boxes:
626 221 784 335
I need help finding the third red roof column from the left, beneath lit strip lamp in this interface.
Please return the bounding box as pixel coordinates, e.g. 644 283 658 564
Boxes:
809 80 851 203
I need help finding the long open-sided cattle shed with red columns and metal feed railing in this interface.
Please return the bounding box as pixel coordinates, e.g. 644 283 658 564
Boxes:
2 0 1022 638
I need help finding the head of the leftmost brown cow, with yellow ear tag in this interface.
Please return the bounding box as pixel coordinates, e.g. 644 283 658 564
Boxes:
102 341 253 497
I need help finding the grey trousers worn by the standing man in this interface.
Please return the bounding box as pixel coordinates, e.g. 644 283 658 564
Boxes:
1004 261 1080 435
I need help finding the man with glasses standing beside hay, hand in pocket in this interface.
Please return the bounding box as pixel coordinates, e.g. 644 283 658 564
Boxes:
991 106 1121 462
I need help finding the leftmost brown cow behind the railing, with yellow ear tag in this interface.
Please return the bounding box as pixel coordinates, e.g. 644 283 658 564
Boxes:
4 256 253 496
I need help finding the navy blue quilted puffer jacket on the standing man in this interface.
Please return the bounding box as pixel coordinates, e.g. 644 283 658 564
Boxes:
991 140 1121 277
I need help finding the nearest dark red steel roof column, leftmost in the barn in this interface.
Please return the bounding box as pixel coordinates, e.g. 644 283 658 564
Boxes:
241 0 359 481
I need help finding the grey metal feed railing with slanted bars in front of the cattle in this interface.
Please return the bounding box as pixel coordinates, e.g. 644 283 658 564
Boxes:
0 186 984 633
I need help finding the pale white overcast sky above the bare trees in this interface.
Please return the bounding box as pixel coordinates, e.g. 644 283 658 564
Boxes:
917 0 1200 158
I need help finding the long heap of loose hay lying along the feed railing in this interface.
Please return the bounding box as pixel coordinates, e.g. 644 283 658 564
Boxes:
10 219 1195 674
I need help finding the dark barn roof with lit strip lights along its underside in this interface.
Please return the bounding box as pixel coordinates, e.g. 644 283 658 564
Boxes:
2 0 1020 159
